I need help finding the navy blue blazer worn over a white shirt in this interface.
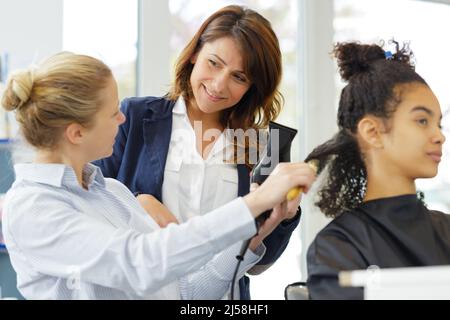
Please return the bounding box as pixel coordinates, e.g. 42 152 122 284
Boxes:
94 97 300 300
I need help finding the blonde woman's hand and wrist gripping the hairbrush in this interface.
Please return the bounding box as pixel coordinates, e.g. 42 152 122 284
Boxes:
243 162 316 218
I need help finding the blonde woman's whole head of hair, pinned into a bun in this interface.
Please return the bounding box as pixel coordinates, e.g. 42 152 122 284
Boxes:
2 52 113 149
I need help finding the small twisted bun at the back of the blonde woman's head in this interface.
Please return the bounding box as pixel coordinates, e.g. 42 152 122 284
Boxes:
2 70 34 111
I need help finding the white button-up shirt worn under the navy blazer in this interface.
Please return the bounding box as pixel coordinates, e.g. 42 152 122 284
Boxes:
162 97 265 297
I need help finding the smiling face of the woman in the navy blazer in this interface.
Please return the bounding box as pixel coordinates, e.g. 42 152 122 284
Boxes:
190 37 251 114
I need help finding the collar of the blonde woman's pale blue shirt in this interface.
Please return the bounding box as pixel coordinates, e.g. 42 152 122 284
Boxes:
14 163 105 187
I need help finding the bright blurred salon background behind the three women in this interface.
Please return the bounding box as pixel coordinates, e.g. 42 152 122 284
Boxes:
0 0 450 299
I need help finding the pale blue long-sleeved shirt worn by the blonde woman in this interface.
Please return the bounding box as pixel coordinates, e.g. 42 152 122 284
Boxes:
3 164 256 299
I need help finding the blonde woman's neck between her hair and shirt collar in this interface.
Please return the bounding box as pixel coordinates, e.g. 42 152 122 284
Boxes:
34 150 86 189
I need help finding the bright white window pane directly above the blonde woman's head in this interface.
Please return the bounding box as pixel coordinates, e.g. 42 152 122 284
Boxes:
63 0 138 99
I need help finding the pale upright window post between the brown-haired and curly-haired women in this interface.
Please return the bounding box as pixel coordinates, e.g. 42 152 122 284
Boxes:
293 0 337 281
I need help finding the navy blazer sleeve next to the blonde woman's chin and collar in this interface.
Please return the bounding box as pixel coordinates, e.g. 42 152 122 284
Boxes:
93 99 129 179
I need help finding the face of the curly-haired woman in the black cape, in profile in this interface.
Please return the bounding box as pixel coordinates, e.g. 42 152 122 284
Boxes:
382 83 445 179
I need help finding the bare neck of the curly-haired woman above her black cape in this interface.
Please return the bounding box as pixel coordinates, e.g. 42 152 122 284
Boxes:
364 161 417 201
